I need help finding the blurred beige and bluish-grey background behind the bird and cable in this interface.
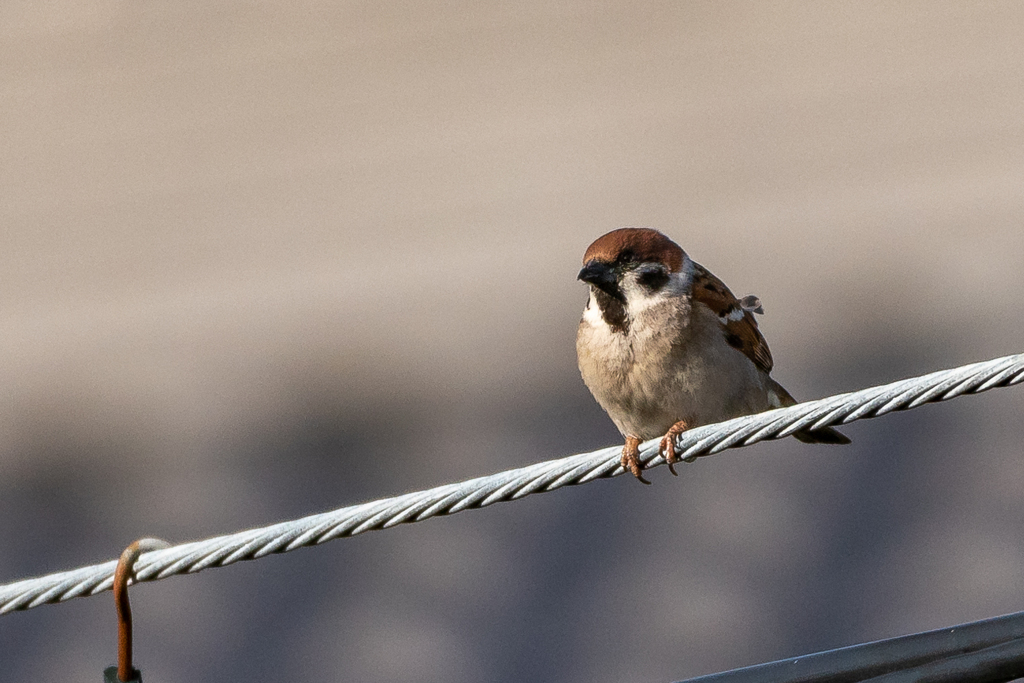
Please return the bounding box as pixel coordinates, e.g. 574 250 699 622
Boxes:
0 0 1024 683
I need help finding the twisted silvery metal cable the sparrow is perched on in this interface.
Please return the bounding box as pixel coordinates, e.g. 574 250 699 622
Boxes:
0 354 1024 614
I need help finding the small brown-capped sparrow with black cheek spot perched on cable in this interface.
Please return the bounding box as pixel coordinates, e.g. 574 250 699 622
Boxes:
577 227 850 483
